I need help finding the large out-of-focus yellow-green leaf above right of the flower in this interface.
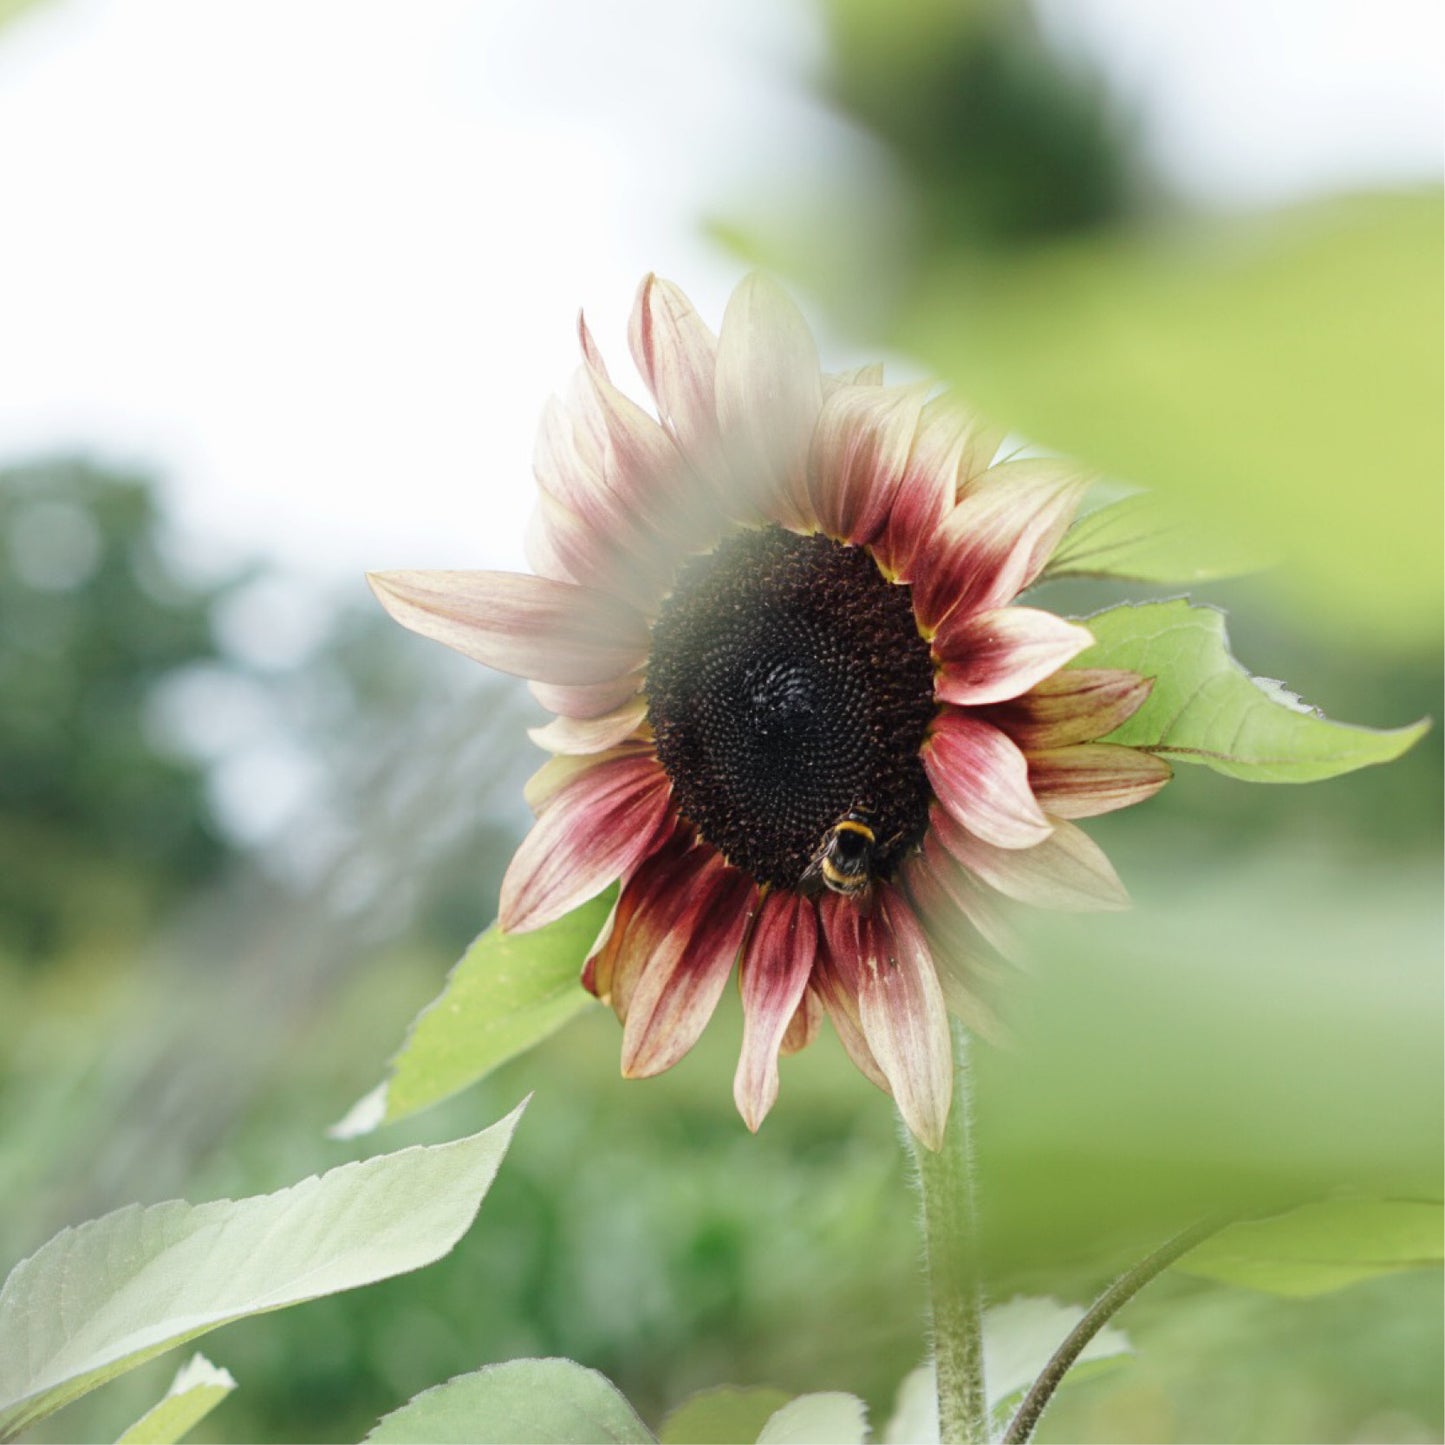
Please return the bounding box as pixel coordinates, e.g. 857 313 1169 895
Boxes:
901 192 1442 639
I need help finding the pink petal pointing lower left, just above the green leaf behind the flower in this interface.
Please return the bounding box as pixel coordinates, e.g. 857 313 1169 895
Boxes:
499 756 672 933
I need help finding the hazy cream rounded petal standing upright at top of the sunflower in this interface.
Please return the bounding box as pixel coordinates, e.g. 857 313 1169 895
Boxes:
717 275 822 525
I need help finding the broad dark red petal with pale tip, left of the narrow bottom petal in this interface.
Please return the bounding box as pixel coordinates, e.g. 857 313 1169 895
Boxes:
623 848 757 1079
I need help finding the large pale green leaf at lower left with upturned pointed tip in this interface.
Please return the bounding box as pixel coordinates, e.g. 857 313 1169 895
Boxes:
0 1105 525 1438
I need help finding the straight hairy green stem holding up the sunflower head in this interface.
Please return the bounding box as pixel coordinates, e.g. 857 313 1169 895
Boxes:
913 1019 988 1445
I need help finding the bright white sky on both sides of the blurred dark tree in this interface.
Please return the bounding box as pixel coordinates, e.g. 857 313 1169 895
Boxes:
0 0 1445 579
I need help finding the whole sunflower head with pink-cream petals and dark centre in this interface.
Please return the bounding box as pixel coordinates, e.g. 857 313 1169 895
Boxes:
371 276 1169 1147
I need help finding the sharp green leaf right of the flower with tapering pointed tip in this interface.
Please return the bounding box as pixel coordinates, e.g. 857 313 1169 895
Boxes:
1074 601 1429 783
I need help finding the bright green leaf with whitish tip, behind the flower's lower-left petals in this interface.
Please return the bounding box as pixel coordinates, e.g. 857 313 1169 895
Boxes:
331 889 617 1139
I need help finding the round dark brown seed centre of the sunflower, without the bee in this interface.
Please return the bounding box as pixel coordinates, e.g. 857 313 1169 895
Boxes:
646 526 935 887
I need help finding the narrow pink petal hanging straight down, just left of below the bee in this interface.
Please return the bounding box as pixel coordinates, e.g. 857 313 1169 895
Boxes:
733 892 818 1133
